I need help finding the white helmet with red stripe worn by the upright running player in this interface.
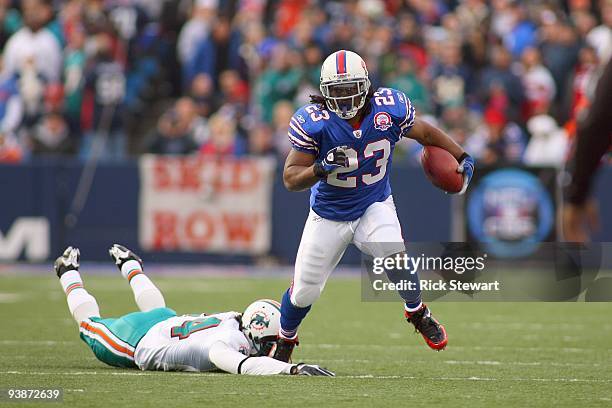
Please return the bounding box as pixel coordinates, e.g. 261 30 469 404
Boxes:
320 50 370 119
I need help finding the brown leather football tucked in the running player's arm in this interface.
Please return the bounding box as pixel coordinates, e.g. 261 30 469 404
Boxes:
421 146 463 193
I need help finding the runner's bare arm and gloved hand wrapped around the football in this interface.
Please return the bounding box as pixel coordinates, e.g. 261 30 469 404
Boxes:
406 118 474 194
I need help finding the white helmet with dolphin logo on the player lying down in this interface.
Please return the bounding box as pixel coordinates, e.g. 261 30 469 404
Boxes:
242 299 280 356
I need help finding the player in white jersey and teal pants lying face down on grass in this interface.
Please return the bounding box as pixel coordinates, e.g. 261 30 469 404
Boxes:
54 244 334 377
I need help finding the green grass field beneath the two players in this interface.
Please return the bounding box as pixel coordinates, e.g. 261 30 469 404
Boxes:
0 273 612 407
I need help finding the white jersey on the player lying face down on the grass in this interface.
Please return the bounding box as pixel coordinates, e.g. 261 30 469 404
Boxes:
134 312 251 371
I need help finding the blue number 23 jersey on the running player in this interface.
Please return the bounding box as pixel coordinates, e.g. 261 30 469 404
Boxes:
289 88 415 221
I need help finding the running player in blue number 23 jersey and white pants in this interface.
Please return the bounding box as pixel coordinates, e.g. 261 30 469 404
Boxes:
274 50 474 361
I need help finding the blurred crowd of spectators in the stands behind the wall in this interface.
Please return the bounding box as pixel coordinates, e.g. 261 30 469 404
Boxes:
0 0 612 165
